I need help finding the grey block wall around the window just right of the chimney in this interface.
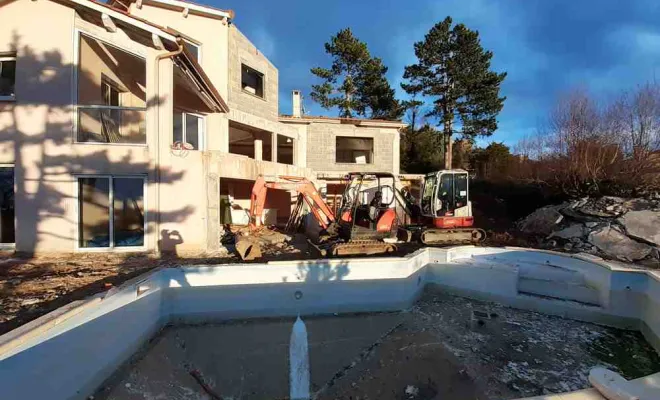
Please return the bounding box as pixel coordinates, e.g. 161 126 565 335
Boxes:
307 122 399 174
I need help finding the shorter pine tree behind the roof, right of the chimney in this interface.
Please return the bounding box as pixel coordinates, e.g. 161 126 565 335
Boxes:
311 28 403 119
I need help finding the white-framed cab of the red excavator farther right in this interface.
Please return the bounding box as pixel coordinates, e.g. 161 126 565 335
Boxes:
420 170 474 228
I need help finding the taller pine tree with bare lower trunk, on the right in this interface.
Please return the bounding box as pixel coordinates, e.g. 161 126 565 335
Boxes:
402 17 506 169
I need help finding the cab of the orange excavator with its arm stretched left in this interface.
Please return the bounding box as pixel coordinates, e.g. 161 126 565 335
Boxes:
337 172 397 240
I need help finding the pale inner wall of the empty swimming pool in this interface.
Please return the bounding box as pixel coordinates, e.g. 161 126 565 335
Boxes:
0 246 660 399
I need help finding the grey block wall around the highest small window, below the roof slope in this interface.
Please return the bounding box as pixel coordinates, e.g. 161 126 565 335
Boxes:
227 25 279 121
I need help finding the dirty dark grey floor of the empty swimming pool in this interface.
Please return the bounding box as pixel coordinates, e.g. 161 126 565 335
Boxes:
95 289 660 400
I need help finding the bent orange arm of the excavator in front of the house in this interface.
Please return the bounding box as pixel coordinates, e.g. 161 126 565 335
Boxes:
250 175 335 229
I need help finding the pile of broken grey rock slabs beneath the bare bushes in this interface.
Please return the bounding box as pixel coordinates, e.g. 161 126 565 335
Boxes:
518 196 660 267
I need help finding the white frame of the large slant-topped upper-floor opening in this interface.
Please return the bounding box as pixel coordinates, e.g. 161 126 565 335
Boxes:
71 28 149 147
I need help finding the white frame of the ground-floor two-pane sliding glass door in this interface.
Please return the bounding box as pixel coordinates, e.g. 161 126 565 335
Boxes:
73 174 149 253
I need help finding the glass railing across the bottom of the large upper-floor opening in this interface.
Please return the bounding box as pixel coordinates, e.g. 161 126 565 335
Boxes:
76 105 147 144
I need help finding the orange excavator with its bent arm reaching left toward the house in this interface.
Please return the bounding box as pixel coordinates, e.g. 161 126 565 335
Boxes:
236 174 397 260
